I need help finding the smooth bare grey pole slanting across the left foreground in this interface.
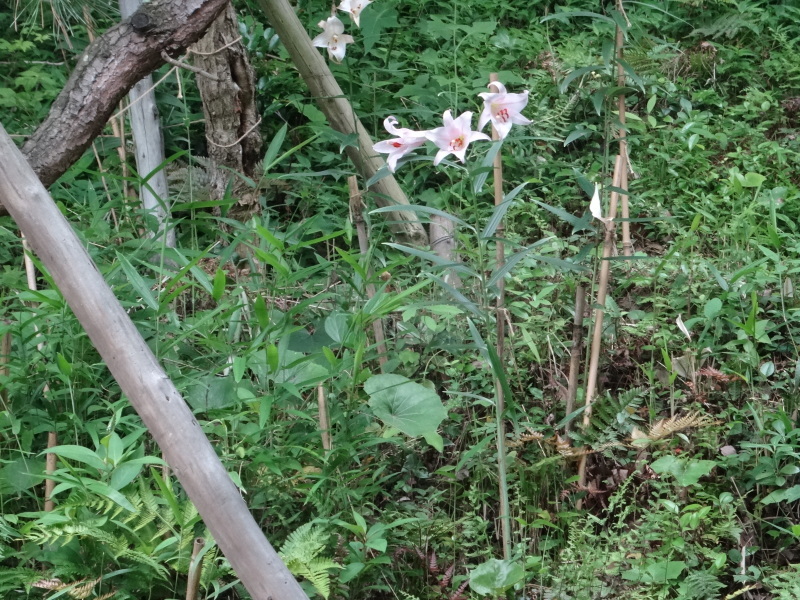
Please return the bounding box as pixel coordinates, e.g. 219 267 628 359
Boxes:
0 125 307 600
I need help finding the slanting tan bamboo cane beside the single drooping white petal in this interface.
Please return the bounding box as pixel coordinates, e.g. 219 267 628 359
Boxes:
578 154 627 496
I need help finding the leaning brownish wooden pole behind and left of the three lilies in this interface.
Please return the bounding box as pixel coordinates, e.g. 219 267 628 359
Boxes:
258 0 428 246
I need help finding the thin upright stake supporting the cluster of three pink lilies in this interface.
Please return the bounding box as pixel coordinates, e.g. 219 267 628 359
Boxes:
489 73 511 560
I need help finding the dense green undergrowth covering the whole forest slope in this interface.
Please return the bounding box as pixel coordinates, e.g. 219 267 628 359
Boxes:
0 0 800 600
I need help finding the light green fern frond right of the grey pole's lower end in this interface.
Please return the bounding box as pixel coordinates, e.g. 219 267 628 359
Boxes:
279 523 341 599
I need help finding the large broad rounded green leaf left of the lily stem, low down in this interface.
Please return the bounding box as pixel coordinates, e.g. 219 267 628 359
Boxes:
364 375 447 437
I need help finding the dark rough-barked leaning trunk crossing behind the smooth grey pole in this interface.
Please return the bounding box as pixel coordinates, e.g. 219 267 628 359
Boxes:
22 0 228 187
